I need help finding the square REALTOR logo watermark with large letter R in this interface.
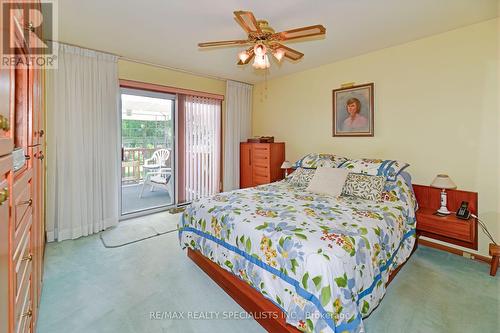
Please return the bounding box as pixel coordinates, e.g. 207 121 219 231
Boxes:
0 0 58 69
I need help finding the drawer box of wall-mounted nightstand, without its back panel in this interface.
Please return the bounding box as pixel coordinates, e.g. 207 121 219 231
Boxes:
417 207 477 250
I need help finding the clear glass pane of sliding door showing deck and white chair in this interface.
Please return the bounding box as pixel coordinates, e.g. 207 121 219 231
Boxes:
121 88 176 215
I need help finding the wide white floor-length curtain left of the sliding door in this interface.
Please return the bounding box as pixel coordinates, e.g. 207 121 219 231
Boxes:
46 44 120 241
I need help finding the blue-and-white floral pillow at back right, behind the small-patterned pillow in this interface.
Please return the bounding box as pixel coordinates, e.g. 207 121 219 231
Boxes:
339 158 410 181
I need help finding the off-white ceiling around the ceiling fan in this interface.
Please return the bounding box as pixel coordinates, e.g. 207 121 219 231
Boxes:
58 0 498 83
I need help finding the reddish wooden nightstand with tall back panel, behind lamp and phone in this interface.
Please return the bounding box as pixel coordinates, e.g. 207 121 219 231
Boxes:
413 185 477 250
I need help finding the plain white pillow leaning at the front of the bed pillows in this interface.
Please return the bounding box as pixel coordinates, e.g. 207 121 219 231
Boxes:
306 167 349 197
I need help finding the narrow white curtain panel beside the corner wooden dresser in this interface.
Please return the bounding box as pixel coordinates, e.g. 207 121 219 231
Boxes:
224 81 253 191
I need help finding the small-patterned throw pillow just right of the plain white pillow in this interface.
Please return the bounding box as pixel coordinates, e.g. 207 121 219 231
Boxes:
342 173 385 201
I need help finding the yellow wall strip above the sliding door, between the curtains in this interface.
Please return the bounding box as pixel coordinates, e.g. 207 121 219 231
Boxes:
118 59 226 95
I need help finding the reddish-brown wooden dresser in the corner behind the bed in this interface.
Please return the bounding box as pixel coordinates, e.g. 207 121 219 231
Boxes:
240 142 285 188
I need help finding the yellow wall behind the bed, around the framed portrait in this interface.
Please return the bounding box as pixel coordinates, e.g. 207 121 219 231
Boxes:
253 19 500 254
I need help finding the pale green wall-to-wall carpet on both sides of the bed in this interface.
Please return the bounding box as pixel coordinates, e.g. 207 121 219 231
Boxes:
37 217 500 333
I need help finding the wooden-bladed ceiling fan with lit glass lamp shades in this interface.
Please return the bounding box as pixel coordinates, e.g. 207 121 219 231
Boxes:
198 10 326 69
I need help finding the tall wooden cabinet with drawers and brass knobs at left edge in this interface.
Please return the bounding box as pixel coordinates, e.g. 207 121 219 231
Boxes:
0 3 45 333
